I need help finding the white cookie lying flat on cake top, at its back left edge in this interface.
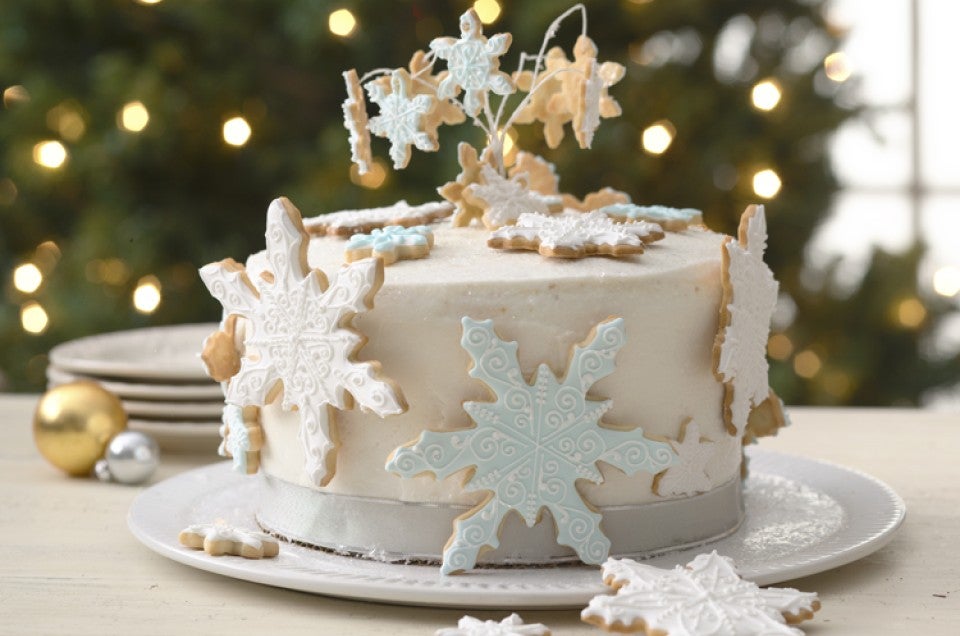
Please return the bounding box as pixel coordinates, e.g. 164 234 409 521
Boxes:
303 200 453 238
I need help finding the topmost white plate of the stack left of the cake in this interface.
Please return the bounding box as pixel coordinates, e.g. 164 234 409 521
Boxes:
50 323 218 382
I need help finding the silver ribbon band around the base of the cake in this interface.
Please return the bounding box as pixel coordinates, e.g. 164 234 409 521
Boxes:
257 472 743 565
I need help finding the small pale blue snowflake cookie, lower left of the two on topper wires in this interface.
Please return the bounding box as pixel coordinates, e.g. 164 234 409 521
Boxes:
366 69 440 170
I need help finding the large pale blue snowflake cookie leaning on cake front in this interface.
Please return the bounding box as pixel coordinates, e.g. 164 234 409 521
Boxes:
387 318 676 574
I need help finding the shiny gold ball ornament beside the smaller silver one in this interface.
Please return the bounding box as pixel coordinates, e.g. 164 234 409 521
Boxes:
33 381 127 476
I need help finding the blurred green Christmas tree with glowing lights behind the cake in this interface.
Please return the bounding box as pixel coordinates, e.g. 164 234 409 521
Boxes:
0 0 960 404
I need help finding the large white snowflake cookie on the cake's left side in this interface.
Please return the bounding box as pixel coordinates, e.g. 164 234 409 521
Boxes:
200 198 406 486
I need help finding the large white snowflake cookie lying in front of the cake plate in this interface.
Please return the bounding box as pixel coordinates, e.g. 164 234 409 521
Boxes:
580 551 820 636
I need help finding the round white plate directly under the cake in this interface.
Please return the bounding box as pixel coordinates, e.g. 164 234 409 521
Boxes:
127 449 906 609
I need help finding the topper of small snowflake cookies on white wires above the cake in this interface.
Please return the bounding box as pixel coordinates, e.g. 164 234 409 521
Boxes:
343 4 656 242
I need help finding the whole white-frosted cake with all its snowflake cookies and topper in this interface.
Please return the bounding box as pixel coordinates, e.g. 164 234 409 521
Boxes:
193 5 785 574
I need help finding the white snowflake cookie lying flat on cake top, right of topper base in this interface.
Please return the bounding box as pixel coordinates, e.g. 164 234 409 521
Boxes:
490 211 661 251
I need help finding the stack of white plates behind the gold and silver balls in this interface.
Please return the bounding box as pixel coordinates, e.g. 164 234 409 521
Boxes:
47 323 223 453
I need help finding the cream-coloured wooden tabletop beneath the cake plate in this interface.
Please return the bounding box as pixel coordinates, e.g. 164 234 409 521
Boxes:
0 395 960 636
